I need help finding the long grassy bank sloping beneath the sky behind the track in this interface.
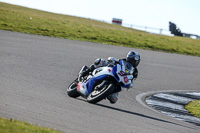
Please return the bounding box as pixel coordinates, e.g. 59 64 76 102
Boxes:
0 2 200 56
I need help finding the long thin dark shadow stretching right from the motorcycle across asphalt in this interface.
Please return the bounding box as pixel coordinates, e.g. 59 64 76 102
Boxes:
95 103 195 129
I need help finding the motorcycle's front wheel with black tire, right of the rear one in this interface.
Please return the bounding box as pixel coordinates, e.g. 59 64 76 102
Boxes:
87 83 115 104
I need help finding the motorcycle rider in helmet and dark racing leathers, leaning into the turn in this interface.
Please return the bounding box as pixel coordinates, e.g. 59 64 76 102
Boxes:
78 51 140 104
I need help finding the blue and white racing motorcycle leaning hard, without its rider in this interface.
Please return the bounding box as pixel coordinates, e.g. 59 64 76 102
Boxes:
67 60 133 104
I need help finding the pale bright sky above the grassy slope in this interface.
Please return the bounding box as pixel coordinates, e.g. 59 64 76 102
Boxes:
0 0 200 35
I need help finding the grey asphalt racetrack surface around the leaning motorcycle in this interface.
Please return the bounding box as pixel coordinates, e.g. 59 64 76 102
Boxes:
0 30 200 133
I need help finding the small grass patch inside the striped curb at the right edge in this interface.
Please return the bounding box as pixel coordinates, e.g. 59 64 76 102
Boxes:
185 100 200 118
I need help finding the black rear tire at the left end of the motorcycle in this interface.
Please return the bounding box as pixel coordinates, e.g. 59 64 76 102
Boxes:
67 80 80 98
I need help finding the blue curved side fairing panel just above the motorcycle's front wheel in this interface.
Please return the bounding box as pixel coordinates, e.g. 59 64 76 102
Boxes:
86 74 109 94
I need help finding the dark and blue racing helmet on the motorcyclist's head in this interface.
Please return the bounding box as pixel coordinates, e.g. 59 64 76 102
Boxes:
126 51 140 67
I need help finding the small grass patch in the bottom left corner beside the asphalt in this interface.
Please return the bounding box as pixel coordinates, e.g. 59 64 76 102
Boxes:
0 118 60 133
